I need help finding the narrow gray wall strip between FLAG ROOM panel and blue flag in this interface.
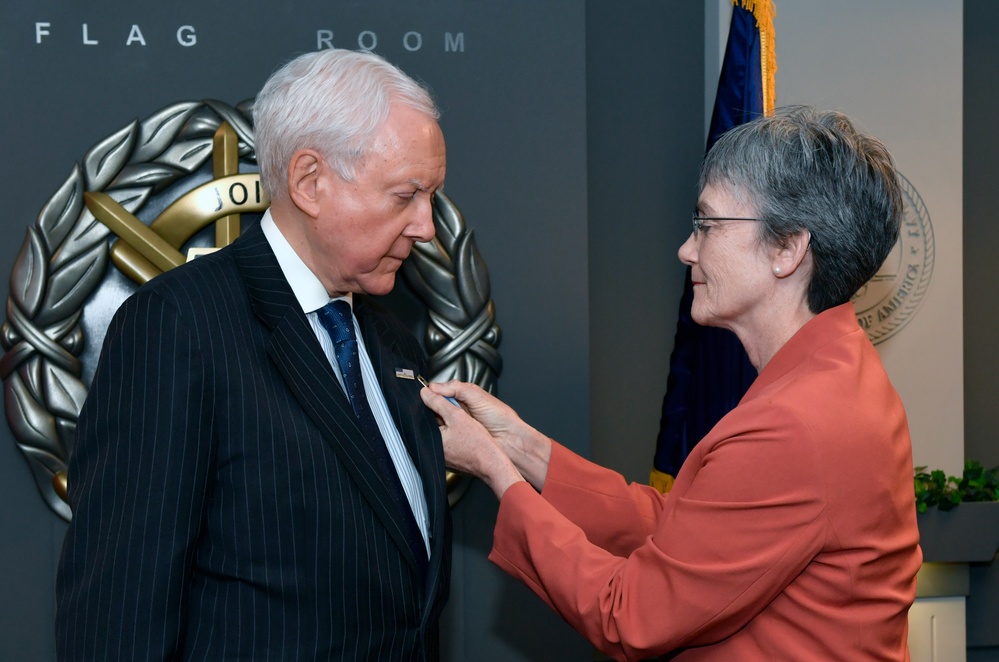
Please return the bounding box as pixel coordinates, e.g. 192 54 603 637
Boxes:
586 1 717 483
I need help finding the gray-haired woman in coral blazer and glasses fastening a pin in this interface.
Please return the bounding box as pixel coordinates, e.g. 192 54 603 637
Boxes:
423 107 922 661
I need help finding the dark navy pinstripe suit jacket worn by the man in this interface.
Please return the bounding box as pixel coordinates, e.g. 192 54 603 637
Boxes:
50 226 451 660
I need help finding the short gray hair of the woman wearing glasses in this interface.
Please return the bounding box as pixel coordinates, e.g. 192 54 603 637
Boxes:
698 106 902 313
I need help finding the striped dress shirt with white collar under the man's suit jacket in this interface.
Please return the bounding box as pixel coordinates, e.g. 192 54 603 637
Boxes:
260 209 430 556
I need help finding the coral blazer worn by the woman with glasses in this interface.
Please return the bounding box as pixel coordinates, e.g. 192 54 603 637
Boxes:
490 304 922 662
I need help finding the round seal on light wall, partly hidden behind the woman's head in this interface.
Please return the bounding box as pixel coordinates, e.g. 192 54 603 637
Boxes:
853 173 934 345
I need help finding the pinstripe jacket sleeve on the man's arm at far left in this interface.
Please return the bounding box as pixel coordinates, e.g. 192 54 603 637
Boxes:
56 291 213 660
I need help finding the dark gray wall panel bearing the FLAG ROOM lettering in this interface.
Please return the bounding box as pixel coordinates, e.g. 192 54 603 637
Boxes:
0 0 590 660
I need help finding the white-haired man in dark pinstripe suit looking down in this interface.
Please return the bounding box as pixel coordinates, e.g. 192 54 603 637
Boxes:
56 50 451 660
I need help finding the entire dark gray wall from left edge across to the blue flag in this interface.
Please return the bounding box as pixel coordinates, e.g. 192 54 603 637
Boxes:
0 0 703 660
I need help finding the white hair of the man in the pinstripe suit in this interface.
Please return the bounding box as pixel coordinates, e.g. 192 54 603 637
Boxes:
253 49 440 198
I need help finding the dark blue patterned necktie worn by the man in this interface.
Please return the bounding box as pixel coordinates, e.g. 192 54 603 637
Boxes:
317 299 427 577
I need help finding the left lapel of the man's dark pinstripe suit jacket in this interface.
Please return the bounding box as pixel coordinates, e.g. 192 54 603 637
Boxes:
232 226 424 568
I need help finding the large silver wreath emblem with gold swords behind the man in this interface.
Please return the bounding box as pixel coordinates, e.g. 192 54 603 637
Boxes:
0 100 502 520
